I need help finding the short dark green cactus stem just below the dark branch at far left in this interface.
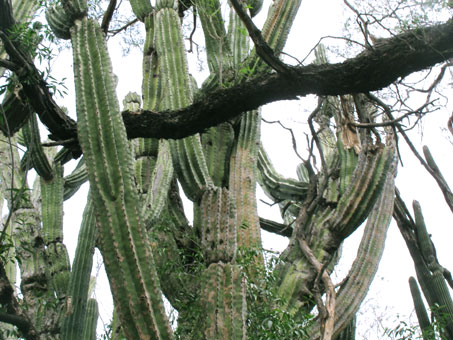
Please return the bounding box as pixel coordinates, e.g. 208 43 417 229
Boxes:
22 114 53 181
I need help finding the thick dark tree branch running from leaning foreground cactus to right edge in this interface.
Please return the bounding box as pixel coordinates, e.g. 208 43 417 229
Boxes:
123 20 453 139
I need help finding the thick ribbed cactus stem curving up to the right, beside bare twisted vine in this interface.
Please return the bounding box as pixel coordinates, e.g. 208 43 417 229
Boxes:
278 141 394 313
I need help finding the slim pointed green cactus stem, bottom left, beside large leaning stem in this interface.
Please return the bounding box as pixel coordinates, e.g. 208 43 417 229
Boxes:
61 195 96 340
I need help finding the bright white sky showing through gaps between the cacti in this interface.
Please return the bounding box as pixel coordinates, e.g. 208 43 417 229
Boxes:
23 0 453 340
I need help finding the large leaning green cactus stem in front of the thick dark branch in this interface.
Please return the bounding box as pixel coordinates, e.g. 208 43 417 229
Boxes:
71 18 172 340
